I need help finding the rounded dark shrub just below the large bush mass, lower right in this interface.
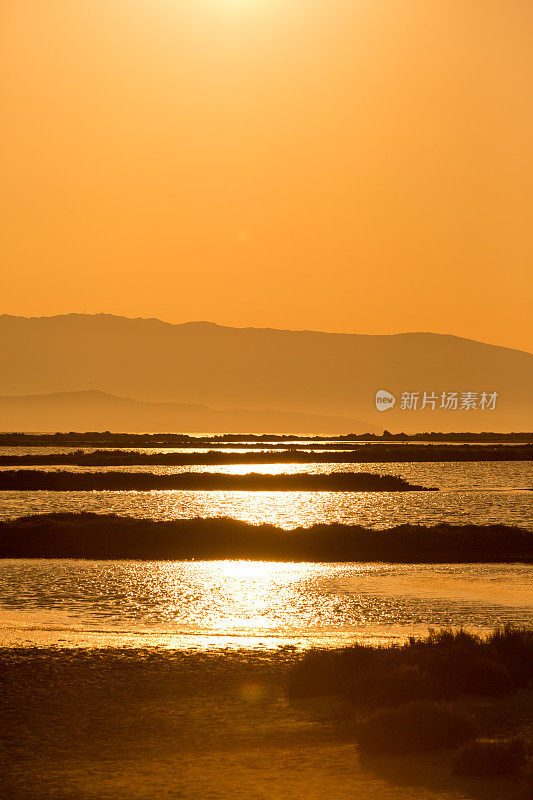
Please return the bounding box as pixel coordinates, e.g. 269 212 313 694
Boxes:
357 702 475 753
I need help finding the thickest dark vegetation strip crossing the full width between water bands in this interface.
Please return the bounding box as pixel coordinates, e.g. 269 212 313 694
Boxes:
0 513 533 563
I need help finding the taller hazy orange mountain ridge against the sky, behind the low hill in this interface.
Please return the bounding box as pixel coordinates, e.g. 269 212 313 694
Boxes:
0 314 533 433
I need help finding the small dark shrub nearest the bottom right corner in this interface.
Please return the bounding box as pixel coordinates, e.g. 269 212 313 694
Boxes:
453 737 526 778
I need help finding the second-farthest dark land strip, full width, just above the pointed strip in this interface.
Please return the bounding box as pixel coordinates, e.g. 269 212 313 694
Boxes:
0 443 533 467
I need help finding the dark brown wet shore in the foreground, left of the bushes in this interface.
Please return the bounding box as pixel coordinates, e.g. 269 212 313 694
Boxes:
0 648 533 800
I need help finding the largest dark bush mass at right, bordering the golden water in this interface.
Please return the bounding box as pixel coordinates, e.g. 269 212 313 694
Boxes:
289 628 533 706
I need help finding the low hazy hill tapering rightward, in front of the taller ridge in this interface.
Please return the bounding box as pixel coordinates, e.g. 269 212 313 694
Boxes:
0 391 375 434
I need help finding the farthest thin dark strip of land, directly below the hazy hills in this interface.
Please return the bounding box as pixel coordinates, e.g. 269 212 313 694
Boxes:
0 431 533 447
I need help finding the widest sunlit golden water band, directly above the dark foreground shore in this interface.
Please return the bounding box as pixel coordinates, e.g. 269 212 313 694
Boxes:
0 560 533 648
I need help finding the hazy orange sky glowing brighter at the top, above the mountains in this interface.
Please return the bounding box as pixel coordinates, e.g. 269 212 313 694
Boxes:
0 0 533 350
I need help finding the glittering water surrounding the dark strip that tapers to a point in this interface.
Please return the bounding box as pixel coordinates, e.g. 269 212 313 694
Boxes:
0 461 533 530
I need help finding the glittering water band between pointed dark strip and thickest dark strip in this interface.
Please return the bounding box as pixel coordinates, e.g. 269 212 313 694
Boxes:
0 490 533 530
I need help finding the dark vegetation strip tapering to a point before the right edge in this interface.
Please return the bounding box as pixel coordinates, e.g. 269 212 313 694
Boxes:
0 469 438 492
